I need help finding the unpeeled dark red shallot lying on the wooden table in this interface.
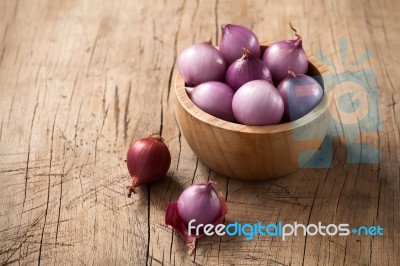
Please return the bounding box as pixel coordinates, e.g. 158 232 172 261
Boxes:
126 134 171 197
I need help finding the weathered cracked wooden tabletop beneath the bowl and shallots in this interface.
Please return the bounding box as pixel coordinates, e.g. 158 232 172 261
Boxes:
0 0 400 265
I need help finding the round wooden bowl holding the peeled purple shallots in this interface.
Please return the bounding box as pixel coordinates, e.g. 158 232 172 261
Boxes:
175 43 330 180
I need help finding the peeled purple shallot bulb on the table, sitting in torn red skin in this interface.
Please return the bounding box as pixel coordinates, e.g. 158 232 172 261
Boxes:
178 182 221 225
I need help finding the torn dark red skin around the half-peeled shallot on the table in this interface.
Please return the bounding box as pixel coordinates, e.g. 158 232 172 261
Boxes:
165 182 228 254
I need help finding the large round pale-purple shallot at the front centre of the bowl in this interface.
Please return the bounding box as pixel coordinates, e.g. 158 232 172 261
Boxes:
232 80 283 126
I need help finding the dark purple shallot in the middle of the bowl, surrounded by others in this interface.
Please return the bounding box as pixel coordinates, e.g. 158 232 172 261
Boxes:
225 49 271 91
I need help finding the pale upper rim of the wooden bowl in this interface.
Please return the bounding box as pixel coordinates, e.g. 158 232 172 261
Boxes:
175 41 331 134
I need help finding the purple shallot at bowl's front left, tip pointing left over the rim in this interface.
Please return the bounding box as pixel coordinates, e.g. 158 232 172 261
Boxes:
186 81 235 122
